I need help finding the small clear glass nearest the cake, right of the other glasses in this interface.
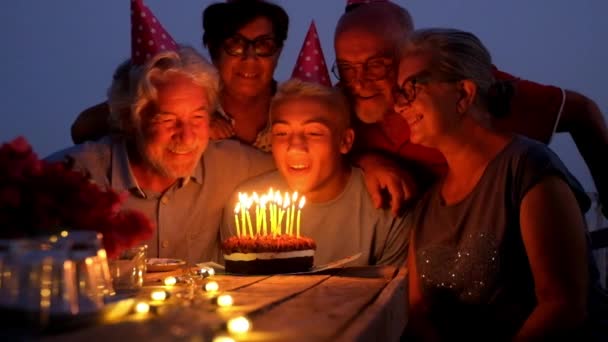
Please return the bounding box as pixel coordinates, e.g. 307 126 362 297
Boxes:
109 245 148 290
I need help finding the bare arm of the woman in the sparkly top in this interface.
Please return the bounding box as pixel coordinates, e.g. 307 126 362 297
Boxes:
516 176 588 341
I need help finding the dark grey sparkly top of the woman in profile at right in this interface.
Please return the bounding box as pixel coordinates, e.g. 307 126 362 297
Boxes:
412 136 601 337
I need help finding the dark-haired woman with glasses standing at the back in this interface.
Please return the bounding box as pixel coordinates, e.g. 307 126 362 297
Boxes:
203 0 289 151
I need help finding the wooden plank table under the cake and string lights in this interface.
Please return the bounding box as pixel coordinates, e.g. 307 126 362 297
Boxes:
39 266 407 342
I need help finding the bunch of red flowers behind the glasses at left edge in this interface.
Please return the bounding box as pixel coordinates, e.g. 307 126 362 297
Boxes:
0 137 154 258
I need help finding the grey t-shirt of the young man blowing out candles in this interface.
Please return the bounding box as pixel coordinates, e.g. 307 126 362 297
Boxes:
222 168 409 266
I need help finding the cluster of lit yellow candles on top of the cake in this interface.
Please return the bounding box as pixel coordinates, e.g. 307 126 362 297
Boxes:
234 188 306 237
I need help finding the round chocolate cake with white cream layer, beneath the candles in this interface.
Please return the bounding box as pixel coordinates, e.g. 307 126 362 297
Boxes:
222 234 316 274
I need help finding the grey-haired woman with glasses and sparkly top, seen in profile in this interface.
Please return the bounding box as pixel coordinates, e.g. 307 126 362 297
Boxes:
394 29 608 341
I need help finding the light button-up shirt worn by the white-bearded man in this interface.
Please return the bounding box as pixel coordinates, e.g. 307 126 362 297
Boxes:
47 137 275 264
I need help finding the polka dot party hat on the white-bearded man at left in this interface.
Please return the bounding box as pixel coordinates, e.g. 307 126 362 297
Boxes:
131 0 177 65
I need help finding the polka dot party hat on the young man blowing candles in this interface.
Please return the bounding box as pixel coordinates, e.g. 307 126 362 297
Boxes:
291 20 331 87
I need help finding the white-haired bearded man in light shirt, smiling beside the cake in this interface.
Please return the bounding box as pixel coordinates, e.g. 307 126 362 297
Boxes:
48 47 274 263
